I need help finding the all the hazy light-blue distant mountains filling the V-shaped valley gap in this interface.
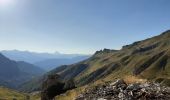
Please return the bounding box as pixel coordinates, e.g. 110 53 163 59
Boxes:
1 50 90 71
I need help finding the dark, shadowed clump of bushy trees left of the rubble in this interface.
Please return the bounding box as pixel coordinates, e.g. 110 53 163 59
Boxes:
41 74 75 100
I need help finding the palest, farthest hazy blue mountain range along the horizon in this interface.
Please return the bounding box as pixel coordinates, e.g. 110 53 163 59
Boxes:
1 50 88 64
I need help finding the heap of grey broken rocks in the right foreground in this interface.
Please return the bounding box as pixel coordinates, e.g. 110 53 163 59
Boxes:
76 80 170 100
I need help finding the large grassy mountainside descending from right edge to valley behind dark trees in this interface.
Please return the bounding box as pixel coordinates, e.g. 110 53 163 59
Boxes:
20 30 170 94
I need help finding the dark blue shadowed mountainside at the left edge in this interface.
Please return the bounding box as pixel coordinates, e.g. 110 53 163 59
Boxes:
0 54 45 88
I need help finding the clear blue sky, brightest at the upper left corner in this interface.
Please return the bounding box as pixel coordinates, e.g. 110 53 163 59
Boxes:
0 0 170 54
